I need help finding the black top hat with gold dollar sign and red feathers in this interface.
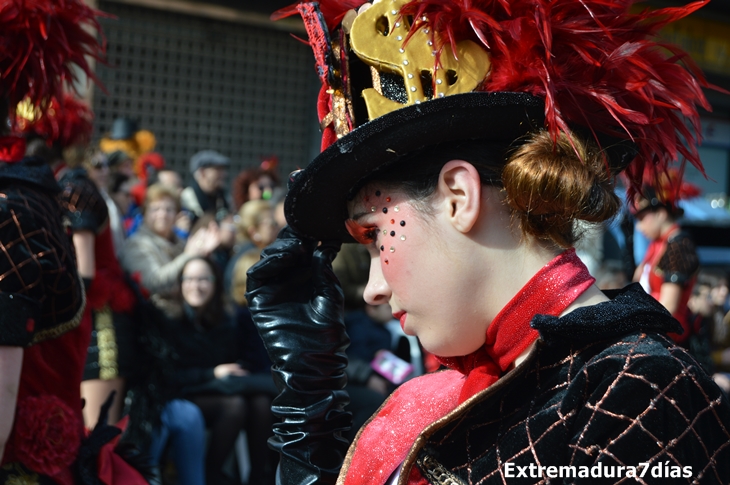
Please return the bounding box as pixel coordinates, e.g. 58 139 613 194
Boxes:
273 0 709 241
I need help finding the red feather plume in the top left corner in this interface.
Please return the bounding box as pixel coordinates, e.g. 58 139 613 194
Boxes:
0 0 105 108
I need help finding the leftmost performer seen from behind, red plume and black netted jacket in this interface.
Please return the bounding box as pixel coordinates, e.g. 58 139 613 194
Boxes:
0 0 146 485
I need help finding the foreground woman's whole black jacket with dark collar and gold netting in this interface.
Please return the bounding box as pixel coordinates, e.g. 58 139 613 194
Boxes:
343 285 730 485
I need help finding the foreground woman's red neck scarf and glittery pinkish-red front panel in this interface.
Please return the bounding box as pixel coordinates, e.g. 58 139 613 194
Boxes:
338 249 595 485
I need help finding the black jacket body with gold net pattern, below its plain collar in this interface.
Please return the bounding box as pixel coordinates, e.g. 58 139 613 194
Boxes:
419 333 730 485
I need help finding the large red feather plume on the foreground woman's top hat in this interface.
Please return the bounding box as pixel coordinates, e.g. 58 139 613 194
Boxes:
401 0 717 197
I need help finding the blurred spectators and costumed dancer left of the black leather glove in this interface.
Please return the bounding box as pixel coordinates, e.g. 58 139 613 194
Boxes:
26 114 290 485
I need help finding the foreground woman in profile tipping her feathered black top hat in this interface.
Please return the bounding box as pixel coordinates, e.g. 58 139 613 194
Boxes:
247 0 730 485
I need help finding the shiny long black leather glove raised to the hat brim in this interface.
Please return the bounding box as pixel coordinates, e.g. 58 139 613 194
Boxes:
246 227 352 485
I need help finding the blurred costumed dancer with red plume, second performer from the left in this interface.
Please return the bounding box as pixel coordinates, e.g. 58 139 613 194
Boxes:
22 94 135 427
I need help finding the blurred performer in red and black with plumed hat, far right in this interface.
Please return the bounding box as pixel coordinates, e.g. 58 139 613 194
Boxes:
632 170 700 348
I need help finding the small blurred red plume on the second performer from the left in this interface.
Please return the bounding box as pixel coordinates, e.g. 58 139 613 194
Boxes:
16 93 94 148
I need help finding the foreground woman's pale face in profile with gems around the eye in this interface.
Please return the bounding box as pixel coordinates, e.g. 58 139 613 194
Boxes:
348 184 488 357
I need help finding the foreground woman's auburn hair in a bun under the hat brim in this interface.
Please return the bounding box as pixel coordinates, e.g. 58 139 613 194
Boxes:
366 130 621 248
